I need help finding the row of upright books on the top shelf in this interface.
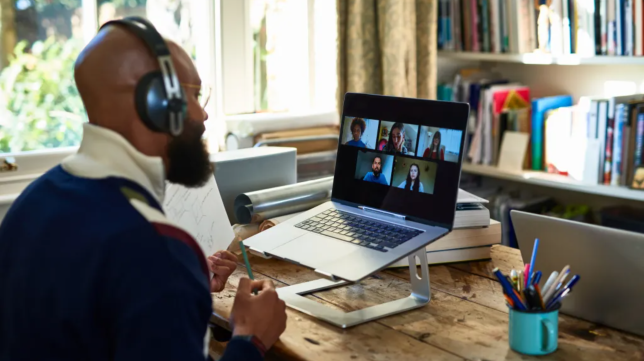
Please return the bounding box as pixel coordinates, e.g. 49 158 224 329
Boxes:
438 0 644 56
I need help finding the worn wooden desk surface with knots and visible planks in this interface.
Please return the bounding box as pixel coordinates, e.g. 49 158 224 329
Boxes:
213 246 644 361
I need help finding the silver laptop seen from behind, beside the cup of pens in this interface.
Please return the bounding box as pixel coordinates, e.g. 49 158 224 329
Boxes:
510 211 644 336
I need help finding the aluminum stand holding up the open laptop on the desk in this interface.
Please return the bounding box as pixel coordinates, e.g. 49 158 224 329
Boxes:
277 247 431 328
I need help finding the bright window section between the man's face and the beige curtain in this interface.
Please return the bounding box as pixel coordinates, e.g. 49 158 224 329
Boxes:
222 0 337 115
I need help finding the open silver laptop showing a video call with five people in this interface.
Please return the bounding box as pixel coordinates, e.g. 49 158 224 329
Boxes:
244 93 469 282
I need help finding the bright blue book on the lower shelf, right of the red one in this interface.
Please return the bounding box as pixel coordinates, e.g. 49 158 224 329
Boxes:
531 95 572 170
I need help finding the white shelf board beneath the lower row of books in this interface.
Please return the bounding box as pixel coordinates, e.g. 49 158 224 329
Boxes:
463 163 644 201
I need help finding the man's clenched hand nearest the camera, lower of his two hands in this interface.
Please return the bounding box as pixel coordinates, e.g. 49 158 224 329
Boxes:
230 278 286 350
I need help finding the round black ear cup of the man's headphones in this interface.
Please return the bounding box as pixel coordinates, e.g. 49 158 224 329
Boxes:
134 71 169 132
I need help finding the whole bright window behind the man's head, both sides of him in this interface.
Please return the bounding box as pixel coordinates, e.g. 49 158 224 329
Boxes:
0 0 336 154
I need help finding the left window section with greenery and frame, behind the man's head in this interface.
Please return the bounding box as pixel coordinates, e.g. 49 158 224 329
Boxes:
0 0 85 153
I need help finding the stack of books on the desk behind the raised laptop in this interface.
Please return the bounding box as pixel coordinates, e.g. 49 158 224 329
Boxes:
389 189 502 268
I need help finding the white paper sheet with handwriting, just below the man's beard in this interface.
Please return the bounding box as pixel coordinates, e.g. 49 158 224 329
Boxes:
163 176 235 257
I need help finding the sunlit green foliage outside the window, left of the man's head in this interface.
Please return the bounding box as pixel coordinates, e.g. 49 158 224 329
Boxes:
0 37 86 153
